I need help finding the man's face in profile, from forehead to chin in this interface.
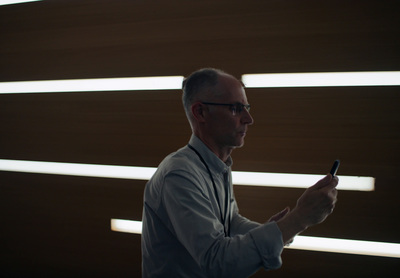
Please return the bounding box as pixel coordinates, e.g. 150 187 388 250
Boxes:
206 75 253 149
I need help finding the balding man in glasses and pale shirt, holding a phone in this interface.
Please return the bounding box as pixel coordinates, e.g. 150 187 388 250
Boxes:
142 68 338 277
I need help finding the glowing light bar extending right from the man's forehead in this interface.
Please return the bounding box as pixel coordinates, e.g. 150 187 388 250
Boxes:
242 71 400 88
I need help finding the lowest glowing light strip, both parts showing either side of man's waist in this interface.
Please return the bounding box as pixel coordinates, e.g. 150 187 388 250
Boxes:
111 219 400 258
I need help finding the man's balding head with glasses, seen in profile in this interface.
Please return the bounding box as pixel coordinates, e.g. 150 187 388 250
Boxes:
182 68 253 159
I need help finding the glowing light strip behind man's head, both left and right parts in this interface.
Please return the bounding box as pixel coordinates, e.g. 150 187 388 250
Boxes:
0 71 400 94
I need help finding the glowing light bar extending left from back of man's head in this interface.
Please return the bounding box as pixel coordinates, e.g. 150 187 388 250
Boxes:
0 76 183 94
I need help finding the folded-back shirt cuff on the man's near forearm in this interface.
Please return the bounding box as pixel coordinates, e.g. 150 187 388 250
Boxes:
250 222 284 269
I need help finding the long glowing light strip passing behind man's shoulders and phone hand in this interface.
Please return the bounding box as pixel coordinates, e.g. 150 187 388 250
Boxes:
0 159 375 191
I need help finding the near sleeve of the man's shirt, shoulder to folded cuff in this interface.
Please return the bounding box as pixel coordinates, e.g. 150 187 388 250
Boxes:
160 171 283 277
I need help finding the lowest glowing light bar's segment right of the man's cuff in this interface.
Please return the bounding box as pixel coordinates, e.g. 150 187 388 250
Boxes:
286 236 400 258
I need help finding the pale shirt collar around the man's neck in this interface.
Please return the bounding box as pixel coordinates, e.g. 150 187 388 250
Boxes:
189 134 233 173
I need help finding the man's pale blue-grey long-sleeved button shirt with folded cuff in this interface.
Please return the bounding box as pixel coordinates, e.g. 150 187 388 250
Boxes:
142 135 284 278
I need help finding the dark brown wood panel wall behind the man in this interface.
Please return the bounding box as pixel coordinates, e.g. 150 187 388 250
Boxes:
0 0 400 277
